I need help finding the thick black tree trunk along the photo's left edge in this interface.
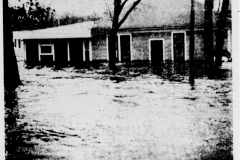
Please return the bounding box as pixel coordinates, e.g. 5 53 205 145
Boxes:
3 0 21 90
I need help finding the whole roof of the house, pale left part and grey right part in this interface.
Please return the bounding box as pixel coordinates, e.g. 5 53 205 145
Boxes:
14 0 223 39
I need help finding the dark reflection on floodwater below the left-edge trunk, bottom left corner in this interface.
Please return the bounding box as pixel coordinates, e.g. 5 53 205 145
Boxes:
4 91 42 160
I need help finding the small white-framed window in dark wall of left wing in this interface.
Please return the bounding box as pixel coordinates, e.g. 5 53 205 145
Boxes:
38 44 55 61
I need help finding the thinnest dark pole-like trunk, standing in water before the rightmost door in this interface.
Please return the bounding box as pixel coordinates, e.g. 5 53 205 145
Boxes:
189 0 195 86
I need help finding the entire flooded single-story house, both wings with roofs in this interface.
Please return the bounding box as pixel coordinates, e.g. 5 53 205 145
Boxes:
14 0 231 65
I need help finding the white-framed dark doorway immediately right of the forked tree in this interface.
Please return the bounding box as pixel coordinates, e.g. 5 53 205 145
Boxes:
120 35 131 62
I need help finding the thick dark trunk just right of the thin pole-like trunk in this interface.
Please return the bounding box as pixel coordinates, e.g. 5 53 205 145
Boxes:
204 0 214 78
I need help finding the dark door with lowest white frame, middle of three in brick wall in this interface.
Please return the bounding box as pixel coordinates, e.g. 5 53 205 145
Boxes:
150 40 163 64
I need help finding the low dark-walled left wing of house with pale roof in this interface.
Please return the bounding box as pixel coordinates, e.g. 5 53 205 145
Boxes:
13 22 94 66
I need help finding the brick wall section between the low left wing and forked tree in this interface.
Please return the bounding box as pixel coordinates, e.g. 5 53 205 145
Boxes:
92 35 107 60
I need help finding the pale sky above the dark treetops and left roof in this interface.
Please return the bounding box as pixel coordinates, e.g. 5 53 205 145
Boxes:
9 0 218 16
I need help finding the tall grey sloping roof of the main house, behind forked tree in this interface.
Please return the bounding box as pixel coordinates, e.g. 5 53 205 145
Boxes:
95 0 204 29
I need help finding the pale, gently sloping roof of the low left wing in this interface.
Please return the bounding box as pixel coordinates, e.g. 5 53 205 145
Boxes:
13 21 94 39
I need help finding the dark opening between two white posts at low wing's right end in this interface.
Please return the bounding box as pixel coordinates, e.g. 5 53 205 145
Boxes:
69 39 83 66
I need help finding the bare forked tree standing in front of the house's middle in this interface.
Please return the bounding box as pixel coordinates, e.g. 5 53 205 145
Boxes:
105 0 141 69
